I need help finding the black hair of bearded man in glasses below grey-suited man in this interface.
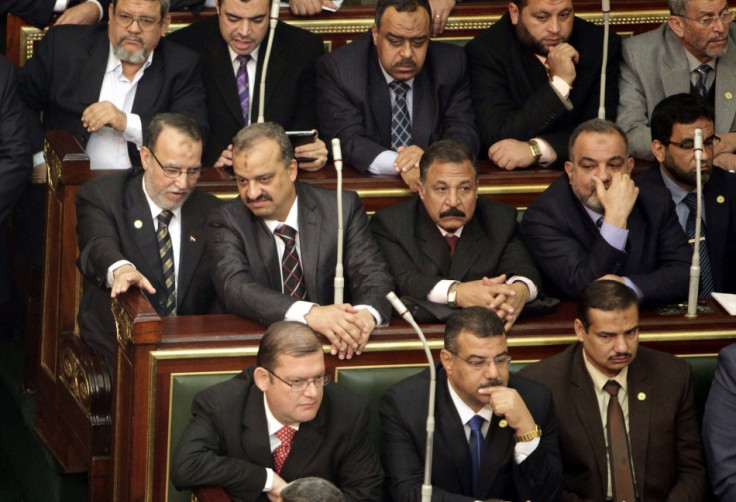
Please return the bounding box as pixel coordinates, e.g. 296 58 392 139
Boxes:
649 93 716 145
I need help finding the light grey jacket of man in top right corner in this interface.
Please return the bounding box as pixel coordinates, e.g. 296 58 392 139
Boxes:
617 23 736 160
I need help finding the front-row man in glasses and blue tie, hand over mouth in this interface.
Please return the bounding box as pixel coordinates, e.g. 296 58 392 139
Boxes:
380 307 562 502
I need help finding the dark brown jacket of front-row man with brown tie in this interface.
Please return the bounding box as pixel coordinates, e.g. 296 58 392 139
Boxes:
520 343 706 502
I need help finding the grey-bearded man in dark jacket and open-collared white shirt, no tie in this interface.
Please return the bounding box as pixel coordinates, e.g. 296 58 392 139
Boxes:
18 0 207 172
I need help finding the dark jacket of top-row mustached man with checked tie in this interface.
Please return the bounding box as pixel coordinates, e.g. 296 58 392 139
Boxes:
317 31 480 172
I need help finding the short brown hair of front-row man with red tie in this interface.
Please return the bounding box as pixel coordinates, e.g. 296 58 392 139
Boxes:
256 321 322 370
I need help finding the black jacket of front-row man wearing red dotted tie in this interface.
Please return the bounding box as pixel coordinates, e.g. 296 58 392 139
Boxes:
171 366 383 502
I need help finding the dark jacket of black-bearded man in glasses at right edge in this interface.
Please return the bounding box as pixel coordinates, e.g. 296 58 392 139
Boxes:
636 166 736 293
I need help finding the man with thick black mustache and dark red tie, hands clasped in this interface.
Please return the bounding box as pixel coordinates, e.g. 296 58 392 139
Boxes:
370 140 541 329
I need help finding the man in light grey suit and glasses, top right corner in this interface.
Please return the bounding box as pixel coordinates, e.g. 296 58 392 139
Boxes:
617 0 736 169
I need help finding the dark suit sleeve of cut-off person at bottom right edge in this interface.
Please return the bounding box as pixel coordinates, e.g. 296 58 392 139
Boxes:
703 344 736 502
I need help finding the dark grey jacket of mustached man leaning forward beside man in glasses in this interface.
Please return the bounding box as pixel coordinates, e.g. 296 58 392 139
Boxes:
208 181 393 324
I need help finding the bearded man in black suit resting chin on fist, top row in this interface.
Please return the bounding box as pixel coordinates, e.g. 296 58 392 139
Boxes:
466 0 621 169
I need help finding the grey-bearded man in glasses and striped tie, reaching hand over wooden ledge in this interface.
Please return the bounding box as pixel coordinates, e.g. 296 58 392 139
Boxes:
77 113 224 371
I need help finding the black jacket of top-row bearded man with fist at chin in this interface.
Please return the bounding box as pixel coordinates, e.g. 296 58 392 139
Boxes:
465 13 621 162
